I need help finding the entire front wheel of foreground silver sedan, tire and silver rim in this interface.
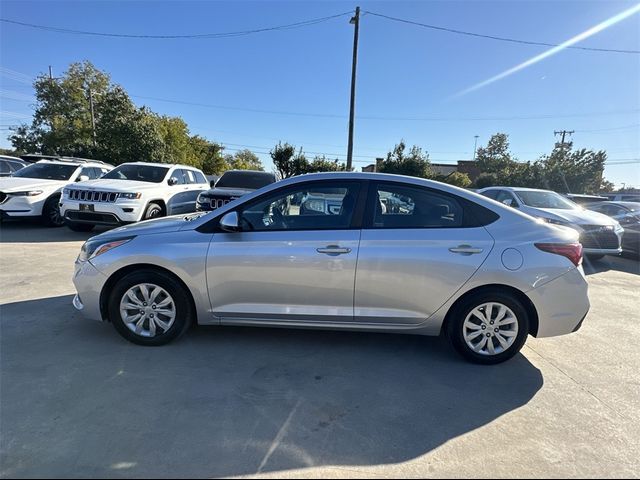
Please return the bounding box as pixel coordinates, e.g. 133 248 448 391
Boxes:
108 270 193 346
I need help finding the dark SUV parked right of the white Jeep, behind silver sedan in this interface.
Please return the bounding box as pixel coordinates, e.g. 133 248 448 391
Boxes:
196 170 277 211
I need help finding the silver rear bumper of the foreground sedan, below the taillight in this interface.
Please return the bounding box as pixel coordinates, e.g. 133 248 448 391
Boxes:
527 268 590 338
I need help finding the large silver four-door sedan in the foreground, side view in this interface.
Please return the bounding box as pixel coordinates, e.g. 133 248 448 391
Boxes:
73 173 589 364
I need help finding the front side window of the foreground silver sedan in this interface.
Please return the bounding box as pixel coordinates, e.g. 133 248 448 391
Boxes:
240 183 360 231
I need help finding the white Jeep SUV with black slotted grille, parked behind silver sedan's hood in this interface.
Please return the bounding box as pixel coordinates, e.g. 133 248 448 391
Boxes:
60 162 209 231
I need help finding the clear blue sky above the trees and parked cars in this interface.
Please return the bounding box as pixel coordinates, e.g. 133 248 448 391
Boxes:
0 1 640 186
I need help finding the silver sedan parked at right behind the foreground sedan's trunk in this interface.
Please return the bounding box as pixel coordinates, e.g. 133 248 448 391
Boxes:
478 187 623 260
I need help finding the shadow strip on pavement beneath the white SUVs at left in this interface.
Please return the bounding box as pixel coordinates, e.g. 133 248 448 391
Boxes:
0 220 106 243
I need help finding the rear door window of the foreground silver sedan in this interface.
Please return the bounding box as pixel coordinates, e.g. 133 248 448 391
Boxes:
370 185 464 228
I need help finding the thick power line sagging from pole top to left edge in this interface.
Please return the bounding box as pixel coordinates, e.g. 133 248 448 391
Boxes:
0 10 353 40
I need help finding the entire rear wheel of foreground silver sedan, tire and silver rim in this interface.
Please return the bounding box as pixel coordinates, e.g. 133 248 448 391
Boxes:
447 291 529 365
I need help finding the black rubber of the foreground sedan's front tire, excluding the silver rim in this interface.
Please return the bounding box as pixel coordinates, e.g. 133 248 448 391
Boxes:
108 270 195 347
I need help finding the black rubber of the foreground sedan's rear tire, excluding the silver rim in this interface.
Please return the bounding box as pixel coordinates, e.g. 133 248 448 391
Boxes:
446 290 529 365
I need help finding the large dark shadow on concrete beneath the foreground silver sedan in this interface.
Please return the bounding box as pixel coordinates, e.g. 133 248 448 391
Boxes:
0 295 543 478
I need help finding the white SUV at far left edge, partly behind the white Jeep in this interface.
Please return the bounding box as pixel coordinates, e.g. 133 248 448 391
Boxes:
0 157 113 227
